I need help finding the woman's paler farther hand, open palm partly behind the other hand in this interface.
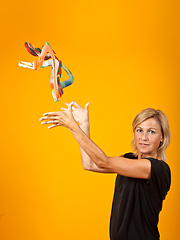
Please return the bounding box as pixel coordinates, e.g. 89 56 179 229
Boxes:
61 102 90 125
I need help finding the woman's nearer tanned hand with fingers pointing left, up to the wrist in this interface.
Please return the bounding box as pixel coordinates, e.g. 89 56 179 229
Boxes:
39 102 77 130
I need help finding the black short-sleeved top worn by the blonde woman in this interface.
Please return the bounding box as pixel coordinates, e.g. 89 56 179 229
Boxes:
110 153 171 240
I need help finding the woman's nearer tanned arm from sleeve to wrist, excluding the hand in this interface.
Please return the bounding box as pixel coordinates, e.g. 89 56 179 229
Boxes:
70 117 151 179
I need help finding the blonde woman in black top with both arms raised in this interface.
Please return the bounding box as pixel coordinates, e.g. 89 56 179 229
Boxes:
40 102 171 240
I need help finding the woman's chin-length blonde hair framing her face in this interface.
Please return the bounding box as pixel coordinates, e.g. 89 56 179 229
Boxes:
131 108 171 160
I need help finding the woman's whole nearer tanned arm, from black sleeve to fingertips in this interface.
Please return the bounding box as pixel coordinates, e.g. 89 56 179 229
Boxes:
40 102 151 179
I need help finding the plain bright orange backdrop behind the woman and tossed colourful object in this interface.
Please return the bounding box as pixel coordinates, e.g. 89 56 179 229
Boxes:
0 0 180 240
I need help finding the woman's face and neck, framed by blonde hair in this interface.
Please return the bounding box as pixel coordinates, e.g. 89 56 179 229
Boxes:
134 118 163 158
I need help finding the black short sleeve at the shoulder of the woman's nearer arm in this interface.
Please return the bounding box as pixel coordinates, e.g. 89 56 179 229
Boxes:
148 158 171 201
